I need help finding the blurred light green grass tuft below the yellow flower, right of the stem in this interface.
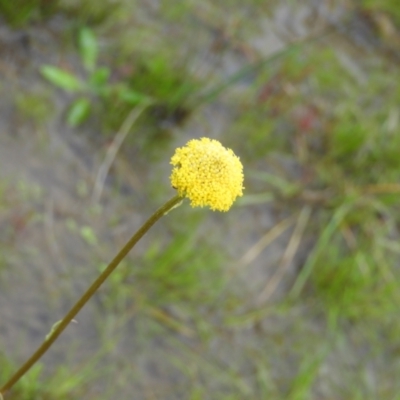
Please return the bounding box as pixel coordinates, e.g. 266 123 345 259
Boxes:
95 225 224 312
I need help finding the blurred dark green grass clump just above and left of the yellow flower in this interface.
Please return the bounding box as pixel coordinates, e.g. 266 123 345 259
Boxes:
103 52 199 142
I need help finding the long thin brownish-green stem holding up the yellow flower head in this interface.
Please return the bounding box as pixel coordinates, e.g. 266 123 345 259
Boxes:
0 196 182 399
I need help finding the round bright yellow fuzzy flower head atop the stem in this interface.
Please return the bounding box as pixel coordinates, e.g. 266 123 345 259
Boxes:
171 138 243 211
